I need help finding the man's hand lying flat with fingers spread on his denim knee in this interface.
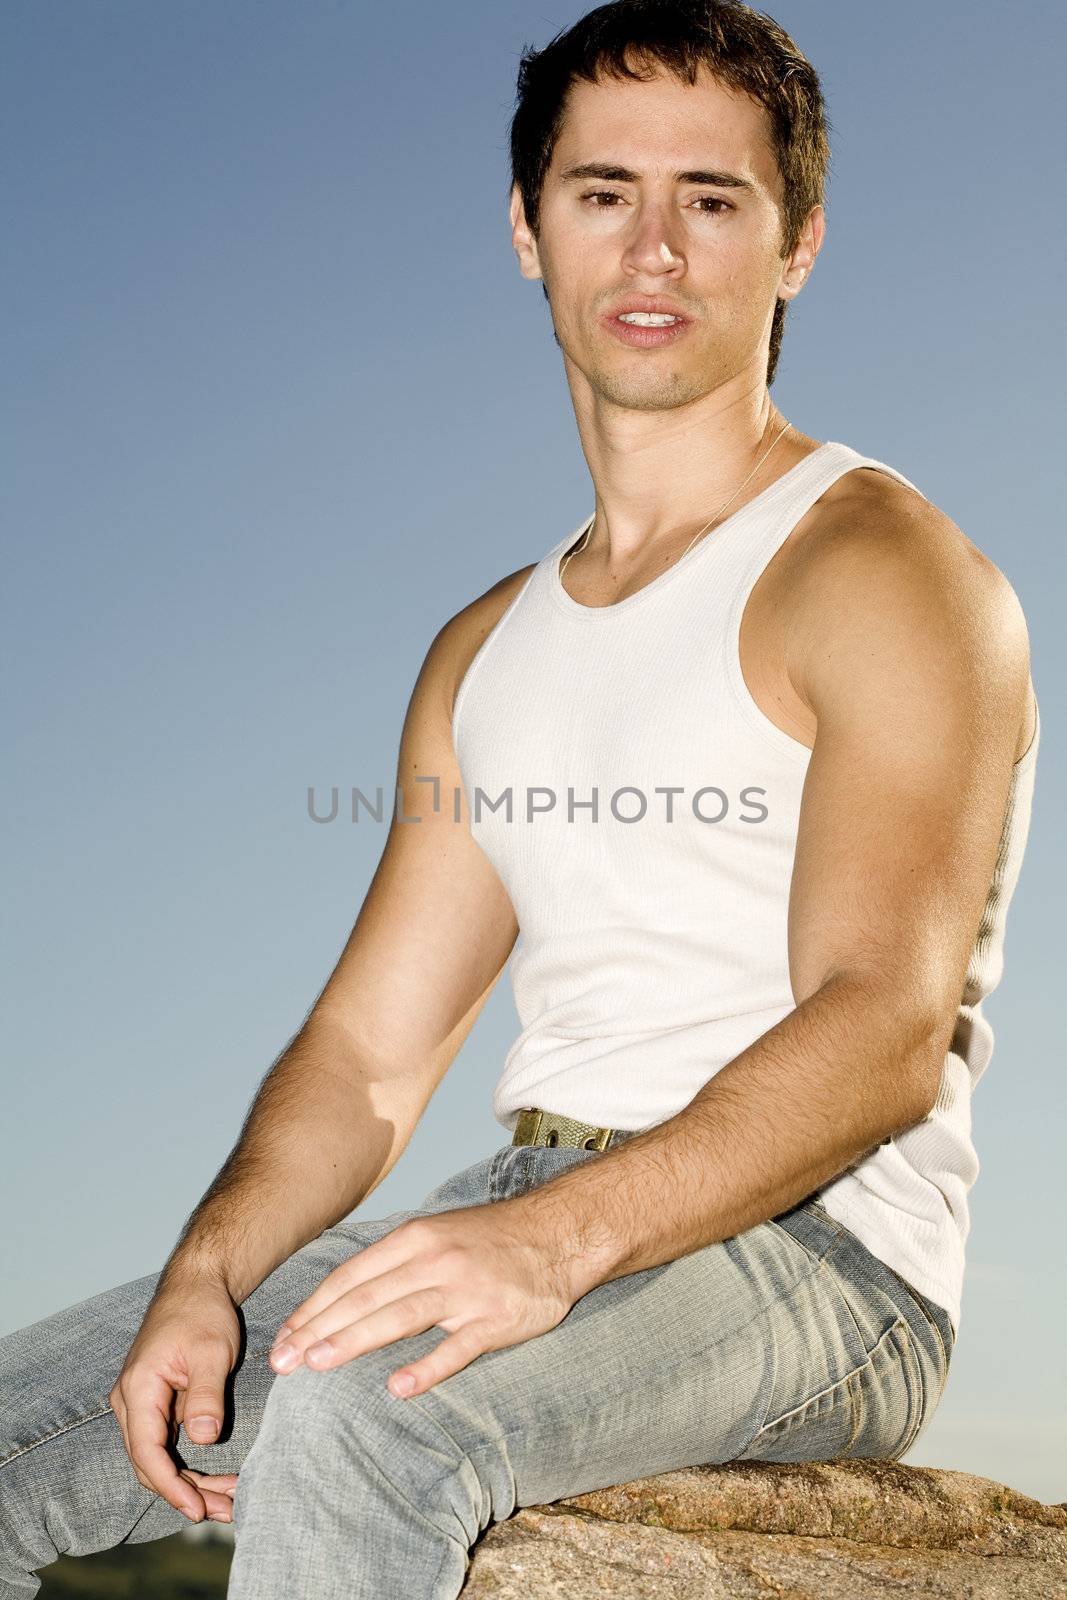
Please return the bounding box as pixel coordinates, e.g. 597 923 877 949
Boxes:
270 1195 581 1395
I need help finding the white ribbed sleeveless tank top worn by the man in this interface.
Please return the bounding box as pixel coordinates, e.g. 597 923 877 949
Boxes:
453 440 1040 1326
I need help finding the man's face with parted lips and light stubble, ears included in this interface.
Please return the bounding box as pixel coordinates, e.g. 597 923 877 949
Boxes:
512 70 824 410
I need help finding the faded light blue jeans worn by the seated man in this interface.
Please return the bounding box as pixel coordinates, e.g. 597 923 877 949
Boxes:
0 1144 952 1600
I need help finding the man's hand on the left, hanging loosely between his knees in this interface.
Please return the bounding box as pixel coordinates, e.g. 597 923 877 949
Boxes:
107 1280 240 1522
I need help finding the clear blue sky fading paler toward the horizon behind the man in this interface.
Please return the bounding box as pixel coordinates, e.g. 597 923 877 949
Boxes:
0 0 1067 1501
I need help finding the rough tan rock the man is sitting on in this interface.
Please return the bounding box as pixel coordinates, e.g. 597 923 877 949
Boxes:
462 1461 1067 1600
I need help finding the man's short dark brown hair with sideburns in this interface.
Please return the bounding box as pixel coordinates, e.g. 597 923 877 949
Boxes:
509 0 830 386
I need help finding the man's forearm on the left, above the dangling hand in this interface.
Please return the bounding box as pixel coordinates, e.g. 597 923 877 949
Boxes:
157 1016 426 1304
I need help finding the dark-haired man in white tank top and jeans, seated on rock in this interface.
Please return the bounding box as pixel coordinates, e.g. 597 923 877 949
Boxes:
0 0 1038 1600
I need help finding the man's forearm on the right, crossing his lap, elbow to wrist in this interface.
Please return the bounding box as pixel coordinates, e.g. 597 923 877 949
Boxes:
517 978 947 1293
